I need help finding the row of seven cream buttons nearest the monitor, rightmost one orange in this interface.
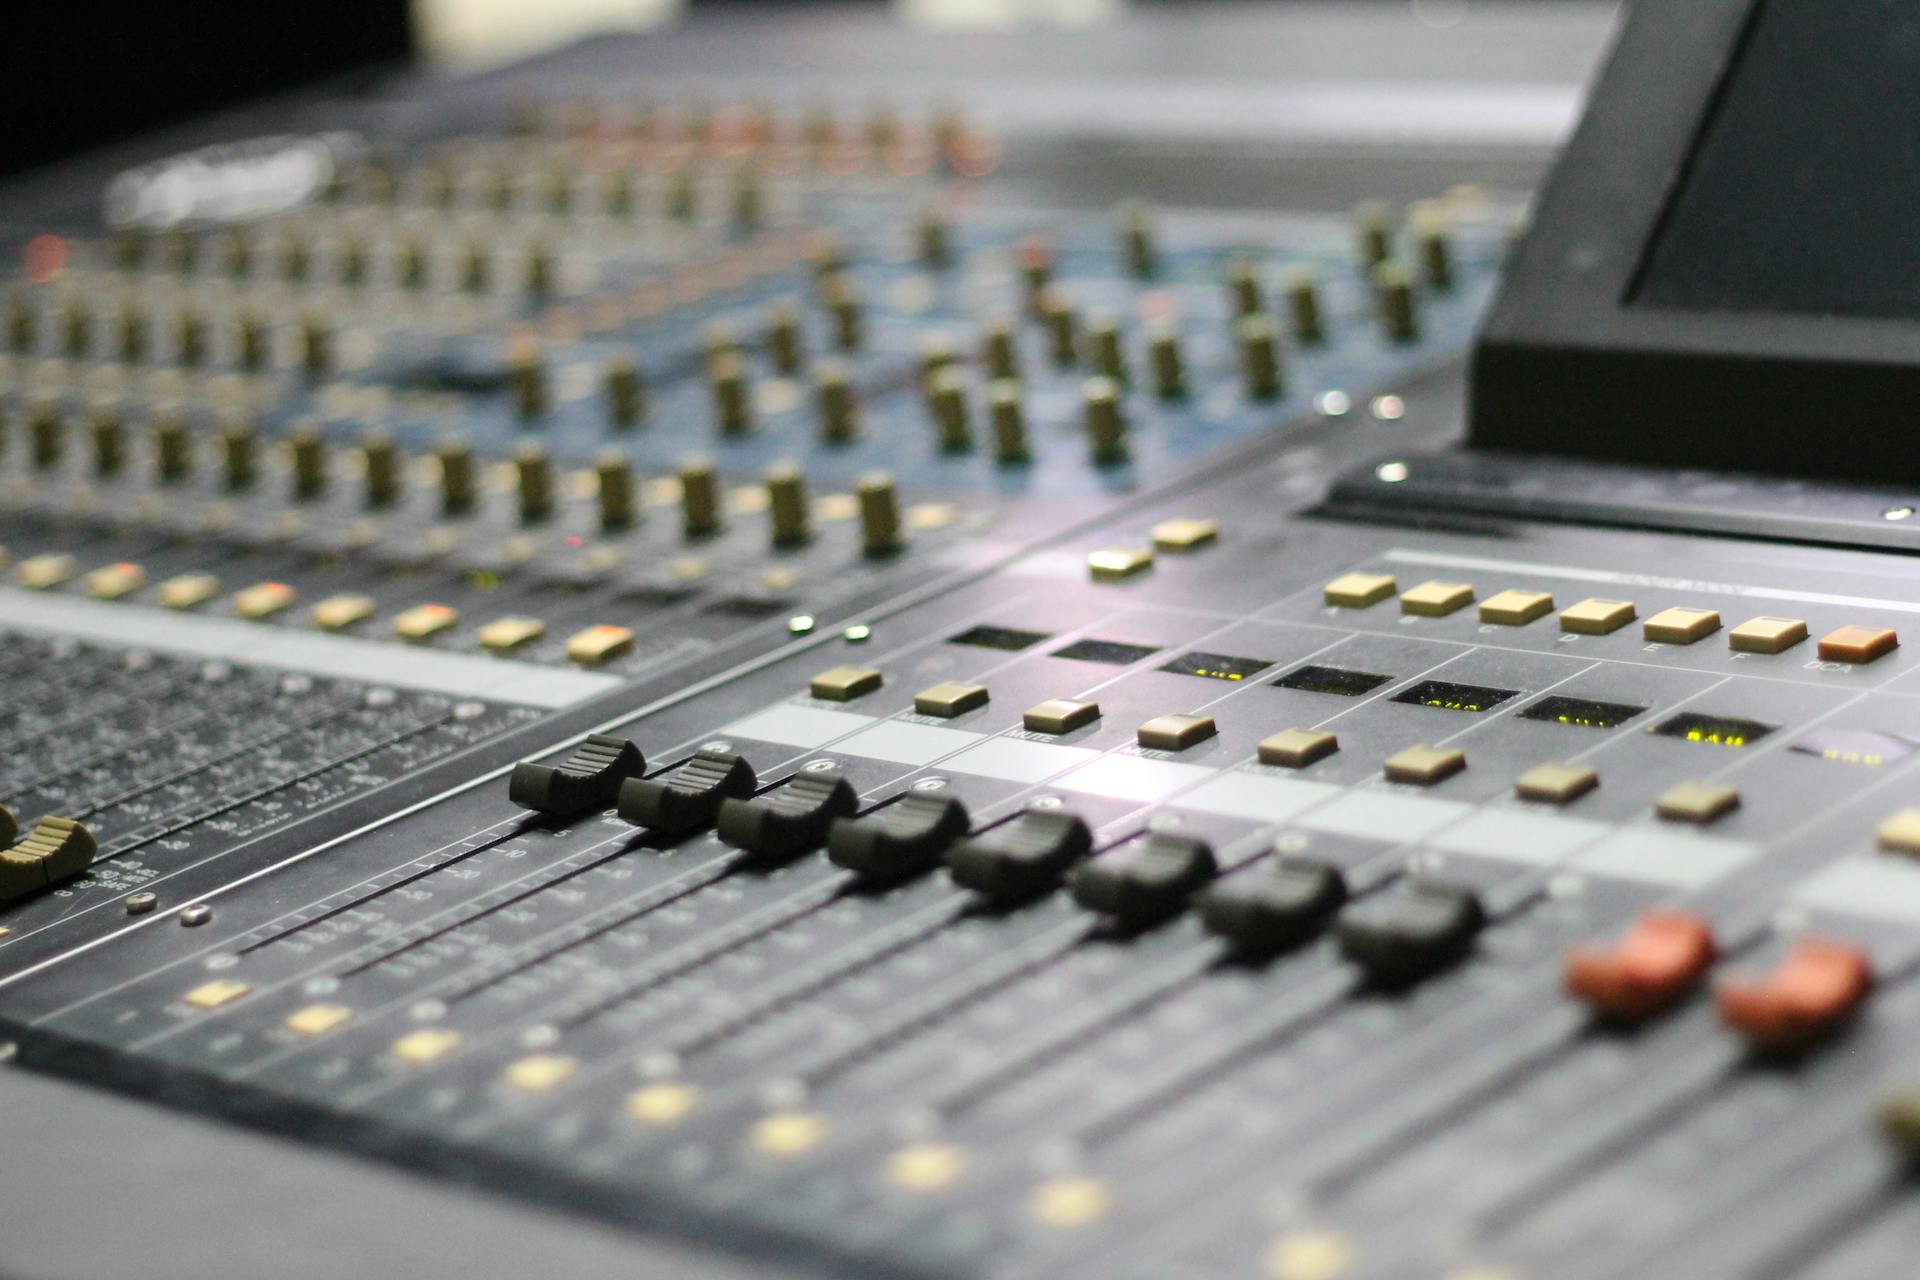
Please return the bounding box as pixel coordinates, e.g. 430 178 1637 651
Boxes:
1323 574 1901 664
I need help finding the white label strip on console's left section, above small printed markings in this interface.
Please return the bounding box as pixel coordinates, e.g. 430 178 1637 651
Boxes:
0 587 620 708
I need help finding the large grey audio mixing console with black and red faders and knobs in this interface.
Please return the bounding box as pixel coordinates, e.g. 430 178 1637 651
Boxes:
0 0 1920 1280
